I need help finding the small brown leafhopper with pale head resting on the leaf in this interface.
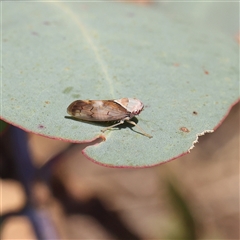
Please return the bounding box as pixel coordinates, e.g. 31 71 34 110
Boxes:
67 98 152 138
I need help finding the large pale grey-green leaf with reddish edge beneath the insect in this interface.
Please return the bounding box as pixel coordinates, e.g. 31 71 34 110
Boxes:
1 2 239 167
